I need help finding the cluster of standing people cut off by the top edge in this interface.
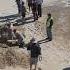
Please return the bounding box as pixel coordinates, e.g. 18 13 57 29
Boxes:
16 0 43 21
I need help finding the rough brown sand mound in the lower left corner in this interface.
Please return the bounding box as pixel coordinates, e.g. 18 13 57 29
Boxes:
0 45 29 68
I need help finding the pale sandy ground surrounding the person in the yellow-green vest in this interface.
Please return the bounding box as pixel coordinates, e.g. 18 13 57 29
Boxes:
1 0 70 70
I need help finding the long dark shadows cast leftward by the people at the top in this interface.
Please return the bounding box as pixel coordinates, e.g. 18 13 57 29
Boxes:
0 14 34 26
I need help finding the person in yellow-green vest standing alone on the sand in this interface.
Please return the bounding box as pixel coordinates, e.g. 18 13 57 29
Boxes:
46 13 53 41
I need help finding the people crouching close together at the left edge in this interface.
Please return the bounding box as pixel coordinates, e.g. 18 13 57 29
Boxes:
1 24 25 48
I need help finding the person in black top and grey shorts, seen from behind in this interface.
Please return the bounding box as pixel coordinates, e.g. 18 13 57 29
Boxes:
27 38 41 70
